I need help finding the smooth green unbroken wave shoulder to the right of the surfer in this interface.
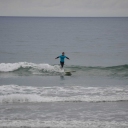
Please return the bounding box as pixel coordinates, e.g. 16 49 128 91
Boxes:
68 64 128 78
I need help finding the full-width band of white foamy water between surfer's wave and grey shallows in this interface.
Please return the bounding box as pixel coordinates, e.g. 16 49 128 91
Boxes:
0 85 128 103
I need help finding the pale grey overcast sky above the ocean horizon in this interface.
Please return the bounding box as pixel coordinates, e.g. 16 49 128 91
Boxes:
0 0 128 17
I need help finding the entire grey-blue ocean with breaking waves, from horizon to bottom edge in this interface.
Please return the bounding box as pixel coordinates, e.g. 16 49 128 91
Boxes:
0 17 128 128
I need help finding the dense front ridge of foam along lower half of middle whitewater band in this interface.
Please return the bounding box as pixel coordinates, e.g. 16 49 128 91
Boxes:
0 94 128 103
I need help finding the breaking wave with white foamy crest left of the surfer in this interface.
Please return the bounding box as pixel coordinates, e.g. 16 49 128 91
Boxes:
0 62 64 75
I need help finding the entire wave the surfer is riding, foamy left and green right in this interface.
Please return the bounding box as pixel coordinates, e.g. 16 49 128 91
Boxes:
0 62 128 78
